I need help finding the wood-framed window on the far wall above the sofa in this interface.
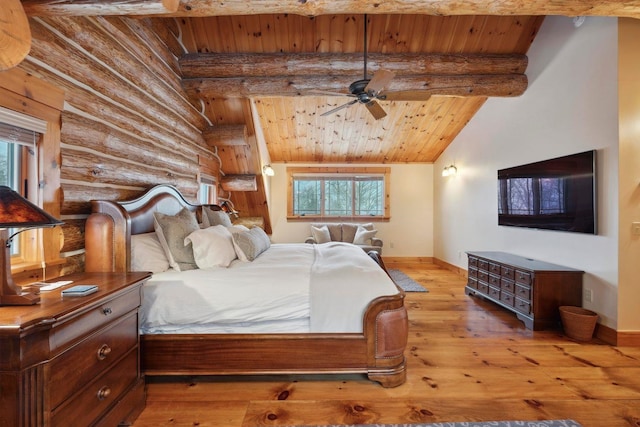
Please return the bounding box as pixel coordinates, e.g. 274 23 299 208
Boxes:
287 168 389 220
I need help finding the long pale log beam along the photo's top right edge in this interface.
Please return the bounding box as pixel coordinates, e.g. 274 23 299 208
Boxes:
156 0 640 18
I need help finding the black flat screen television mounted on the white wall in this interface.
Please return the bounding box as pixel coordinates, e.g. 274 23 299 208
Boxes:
498 150 597 234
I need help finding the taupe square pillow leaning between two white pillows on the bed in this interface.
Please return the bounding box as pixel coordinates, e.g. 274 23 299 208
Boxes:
153 208 200 271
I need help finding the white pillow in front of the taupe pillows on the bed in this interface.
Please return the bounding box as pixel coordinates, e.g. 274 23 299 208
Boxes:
184 225 237 268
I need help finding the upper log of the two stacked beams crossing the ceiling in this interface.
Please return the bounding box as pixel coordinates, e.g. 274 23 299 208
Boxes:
180 53 527 78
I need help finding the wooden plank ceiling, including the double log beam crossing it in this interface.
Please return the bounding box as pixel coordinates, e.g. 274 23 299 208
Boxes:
172 14 543 164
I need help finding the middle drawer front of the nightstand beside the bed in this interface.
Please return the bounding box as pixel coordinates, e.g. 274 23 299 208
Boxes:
50 312 138 408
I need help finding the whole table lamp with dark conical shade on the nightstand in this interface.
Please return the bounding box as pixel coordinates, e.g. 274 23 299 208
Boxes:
0 185 63 306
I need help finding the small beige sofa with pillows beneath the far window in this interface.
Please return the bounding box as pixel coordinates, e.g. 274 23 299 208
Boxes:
305 222 382 255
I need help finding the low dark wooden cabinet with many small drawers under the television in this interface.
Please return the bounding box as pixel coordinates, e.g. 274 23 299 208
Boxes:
465 252 583 330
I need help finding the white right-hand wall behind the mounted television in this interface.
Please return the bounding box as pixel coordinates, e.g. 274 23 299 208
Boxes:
434 17 618 329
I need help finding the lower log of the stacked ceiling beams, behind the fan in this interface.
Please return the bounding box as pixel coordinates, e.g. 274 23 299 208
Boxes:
182 74 527 98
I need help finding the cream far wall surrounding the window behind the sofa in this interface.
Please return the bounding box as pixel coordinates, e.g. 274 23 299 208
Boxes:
269 163 434 257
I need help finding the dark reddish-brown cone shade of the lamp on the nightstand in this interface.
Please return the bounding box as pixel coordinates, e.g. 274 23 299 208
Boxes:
0 185 63 228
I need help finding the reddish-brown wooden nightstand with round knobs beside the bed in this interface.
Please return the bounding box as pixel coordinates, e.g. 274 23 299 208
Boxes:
0 273 150 427
